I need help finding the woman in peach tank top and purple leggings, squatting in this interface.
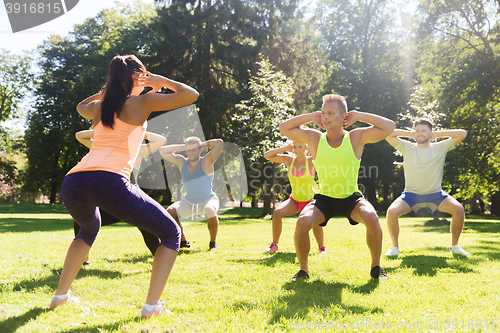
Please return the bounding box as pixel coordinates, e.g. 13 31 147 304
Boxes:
50 55 199 317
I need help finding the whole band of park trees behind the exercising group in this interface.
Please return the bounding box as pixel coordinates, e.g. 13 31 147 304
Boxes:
0 0 500 215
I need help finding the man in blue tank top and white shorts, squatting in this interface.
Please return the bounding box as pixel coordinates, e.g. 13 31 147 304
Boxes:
160 136 224 250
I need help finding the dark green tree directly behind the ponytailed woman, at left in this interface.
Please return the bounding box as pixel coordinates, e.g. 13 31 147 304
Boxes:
25 2 154 203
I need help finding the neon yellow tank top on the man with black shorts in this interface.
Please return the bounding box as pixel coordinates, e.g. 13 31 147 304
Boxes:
314 131 361 199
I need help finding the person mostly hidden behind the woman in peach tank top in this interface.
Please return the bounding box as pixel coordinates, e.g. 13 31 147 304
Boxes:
73 130 167 265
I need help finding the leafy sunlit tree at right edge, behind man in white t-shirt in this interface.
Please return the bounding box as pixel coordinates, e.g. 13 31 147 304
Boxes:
417 0 500 213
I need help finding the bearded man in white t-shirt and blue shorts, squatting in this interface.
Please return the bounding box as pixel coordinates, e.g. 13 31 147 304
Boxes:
385 119 470 256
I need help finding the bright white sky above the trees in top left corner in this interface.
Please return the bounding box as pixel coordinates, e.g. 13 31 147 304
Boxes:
0 0 154 54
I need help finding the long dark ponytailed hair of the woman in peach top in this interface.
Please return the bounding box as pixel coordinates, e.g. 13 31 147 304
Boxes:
101 55 146 128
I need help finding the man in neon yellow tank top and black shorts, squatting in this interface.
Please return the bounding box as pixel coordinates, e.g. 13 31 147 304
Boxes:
280 94 396 281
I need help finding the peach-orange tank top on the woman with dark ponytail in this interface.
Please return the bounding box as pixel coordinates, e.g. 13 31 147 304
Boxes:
67 114 147 179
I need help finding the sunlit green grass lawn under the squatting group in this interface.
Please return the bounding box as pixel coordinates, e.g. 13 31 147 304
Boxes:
0 204 500 333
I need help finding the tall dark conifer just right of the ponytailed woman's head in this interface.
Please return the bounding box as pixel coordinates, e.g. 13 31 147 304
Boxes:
149 0 264 141
